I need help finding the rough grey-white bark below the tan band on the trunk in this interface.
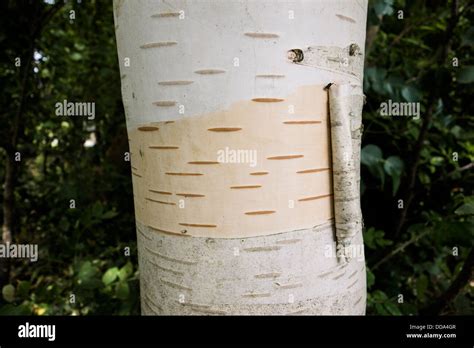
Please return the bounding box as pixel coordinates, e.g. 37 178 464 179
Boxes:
138 222 366 315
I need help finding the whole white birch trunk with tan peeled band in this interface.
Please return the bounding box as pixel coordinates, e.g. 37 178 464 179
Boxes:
114 0 367 315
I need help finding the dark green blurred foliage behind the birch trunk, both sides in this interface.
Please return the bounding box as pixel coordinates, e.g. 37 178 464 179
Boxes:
0 0 474 315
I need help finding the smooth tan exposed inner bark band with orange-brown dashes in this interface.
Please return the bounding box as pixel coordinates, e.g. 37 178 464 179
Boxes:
129 86 334 238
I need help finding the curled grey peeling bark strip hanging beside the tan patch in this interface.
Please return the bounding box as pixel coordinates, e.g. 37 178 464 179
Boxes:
329 84 363 259
